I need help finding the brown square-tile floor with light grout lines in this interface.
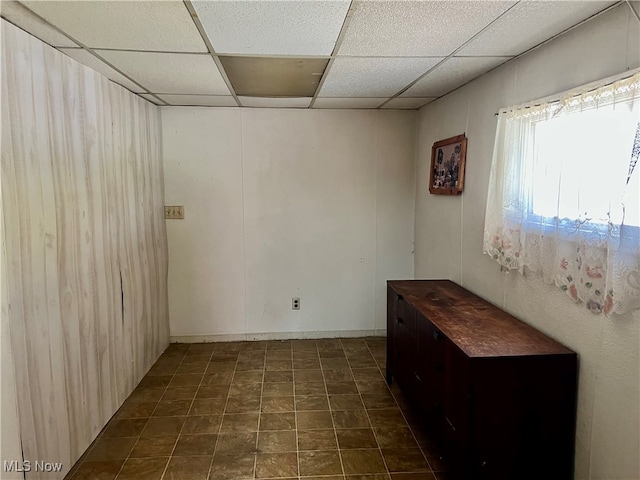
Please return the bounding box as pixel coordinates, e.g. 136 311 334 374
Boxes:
67 337 446 480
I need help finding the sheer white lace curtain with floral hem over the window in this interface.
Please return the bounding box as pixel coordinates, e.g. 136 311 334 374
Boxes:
484 73 640 315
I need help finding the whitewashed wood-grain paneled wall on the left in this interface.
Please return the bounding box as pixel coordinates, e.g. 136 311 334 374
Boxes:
1 20 169 479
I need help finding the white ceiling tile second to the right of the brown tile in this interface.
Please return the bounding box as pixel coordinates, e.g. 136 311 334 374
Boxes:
401 57 510 97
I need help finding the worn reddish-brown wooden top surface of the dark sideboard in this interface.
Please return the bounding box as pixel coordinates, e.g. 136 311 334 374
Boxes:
387 280 575 357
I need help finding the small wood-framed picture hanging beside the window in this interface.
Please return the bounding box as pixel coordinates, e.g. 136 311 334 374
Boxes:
429 133 467 195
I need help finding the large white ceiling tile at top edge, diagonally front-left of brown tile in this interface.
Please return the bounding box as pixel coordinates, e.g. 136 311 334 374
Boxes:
24 0 207 52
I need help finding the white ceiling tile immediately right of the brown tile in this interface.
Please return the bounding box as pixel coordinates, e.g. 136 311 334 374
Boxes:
319 58 442 98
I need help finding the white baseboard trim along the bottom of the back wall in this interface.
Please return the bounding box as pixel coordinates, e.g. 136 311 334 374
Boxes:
170 328 387 343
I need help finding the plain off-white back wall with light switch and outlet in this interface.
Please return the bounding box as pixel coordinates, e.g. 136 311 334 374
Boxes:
162 107 416 341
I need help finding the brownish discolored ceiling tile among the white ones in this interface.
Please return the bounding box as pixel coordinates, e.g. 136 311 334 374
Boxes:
220 57 329 97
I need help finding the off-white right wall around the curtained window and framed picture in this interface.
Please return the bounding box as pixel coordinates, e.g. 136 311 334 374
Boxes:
415 2 640 480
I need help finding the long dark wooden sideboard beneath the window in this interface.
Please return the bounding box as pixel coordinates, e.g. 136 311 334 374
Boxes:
387 280 577 480
